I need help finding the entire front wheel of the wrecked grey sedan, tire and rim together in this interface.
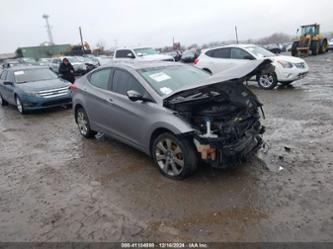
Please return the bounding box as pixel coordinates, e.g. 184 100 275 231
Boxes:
152 132 198 180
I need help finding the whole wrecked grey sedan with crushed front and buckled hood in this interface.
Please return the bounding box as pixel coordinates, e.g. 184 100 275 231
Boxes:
71 60 271 179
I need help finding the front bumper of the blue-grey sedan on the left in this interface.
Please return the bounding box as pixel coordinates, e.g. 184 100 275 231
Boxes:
20 93 72 110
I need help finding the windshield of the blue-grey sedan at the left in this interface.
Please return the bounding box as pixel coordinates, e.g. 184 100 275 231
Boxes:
14 68 58 83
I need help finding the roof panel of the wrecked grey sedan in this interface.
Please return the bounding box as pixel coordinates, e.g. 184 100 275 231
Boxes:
101 59 186 70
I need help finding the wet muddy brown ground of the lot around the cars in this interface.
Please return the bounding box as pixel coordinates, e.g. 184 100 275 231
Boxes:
0 53 333 242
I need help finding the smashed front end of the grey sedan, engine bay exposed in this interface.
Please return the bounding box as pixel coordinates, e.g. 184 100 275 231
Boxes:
164 59 270 168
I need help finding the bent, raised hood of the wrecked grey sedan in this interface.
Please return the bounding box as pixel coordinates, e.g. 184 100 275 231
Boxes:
163 59 274 109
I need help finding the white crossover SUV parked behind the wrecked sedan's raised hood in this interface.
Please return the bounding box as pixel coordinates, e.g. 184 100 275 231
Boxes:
194 44 309 89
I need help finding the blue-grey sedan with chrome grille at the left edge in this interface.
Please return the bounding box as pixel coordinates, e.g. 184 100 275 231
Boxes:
0 66 72 114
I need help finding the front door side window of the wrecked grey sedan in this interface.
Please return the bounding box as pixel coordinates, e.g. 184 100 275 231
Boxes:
112 69 146 95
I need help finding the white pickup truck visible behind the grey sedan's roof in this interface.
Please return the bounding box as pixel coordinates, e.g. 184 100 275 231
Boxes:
113 47 175 61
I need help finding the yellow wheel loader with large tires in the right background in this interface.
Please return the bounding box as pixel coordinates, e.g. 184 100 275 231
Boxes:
291 23 328 56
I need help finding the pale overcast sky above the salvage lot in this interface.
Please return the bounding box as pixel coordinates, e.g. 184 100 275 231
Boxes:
0 0 333 53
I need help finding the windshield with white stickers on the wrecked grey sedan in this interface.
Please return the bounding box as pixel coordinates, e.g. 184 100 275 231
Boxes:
138 65 210 96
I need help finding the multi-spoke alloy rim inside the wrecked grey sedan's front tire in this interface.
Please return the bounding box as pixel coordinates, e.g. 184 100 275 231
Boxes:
155 138 185 176
